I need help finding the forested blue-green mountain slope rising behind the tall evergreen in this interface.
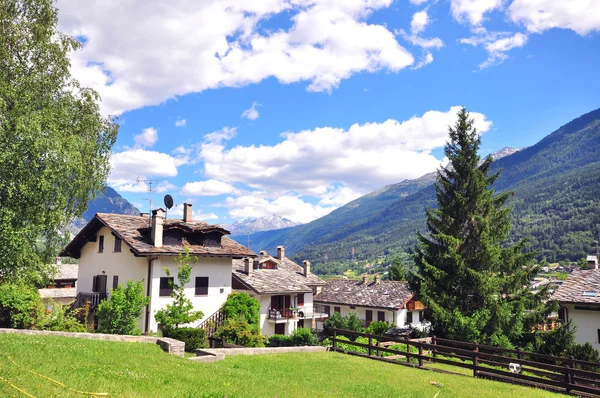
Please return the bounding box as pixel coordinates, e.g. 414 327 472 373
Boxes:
237 109 600 264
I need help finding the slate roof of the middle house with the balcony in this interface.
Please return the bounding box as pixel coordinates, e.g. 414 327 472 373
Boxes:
232 255 326 294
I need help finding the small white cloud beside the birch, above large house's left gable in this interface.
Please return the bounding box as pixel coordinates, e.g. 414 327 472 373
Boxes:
108 149 177 192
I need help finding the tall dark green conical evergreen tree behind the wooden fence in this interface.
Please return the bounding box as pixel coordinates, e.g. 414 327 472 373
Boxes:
410 108 549 346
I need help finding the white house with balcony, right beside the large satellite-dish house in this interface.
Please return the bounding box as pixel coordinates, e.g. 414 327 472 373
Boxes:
232 246 327 336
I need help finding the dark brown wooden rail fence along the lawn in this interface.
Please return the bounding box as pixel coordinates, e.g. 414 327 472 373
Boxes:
331 329 600 397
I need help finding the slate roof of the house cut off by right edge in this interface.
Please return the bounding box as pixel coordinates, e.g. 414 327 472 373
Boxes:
552 269 600 304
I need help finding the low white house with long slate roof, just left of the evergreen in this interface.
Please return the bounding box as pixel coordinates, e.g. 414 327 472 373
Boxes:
313 275 429 330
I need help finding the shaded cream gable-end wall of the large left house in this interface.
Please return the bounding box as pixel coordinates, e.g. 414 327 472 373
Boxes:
76 227 148 331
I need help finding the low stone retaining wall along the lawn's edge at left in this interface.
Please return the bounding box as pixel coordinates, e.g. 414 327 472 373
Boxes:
0 328 185 357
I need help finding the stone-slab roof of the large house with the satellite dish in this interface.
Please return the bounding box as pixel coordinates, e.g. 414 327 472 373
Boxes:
61 213 256 258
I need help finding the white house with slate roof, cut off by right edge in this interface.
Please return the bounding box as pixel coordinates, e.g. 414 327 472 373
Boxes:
551 266 600 351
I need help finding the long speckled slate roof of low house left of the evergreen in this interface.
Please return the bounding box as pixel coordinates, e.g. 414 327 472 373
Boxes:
313 279 414 310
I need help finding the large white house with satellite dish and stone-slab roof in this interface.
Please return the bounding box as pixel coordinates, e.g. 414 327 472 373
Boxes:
61 203 256 332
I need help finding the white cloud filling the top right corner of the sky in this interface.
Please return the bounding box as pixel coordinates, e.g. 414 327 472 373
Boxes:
507 0 600 36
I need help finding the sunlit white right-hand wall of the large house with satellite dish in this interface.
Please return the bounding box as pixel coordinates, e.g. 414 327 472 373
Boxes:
150 256 231 332
